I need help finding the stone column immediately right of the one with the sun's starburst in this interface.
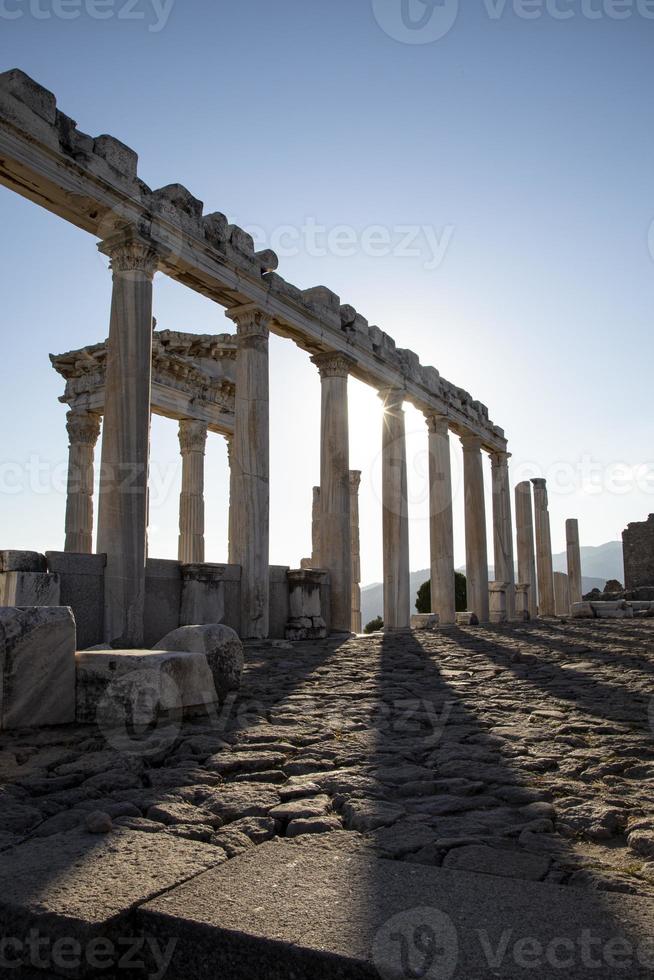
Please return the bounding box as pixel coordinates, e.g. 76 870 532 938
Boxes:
427 415 456 624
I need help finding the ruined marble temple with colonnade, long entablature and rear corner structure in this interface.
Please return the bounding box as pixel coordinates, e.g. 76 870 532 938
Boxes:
0 70 578 668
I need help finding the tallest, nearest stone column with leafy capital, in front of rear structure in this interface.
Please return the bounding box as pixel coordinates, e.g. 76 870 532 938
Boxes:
97 230 157 648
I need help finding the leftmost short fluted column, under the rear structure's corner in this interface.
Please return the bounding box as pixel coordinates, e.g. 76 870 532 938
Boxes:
64 408 100 555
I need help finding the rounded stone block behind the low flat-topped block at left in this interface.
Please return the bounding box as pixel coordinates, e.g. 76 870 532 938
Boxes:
154 623 243 703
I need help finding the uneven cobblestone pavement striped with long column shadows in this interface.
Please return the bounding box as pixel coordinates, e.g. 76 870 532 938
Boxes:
0 620 654 895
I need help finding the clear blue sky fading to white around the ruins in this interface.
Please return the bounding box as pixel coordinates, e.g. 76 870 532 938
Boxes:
0 0 654 583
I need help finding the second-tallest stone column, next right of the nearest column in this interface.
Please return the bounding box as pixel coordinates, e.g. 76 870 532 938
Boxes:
227 305 270 639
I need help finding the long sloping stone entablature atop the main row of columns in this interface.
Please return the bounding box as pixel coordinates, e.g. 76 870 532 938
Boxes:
0 70 506 452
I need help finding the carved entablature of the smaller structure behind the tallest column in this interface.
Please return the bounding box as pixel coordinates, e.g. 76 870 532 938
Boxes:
50 330 236 435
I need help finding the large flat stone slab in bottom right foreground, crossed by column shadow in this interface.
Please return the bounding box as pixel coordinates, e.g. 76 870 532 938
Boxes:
136 838 654 980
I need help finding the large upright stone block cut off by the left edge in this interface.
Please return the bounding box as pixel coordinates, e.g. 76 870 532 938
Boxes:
0 606 76 729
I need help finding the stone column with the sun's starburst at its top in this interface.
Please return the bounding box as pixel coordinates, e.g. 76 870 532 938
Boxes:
379 388 411 630
